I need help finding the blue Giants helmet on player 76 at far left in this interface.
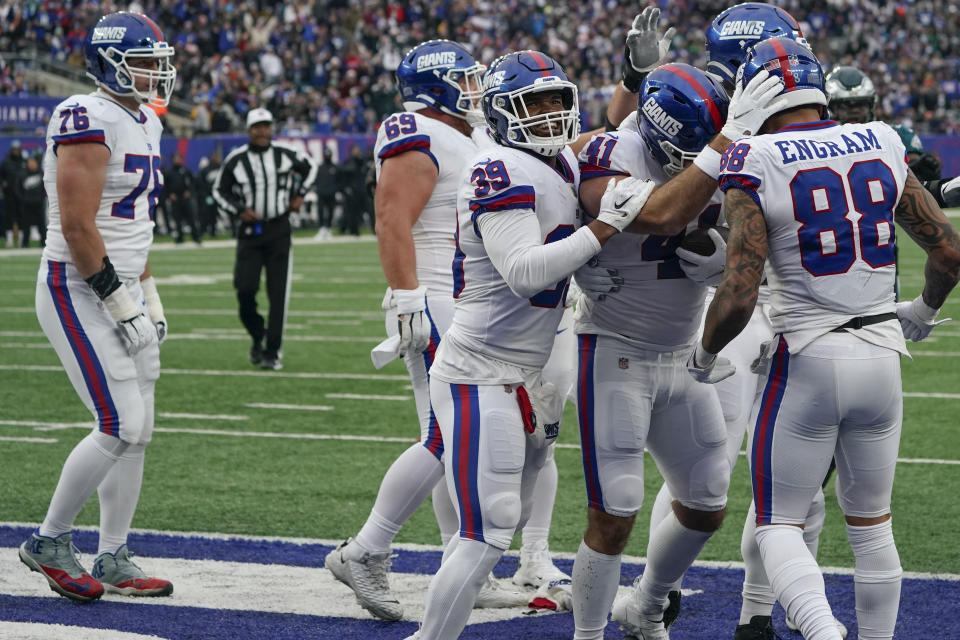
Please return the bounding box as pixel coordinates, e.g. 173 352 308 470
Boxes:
84 11 177 106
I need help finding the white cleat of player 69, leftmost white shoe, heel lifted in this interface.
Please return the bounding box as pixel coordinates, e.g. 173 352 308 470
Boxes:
323 538 403 622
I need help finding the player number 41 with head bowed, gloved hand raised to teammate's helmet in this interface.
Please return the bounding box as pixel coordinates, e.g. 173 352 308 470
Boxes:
573 64 760 640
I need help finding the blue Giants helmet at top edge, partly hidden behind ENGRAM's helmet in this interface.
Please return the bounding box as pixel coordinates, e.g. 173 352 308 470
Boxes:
707 2 806 86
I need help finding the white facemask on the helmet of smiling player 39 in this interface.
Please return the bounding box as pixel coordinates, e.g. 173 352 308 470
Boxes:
490 76 580 157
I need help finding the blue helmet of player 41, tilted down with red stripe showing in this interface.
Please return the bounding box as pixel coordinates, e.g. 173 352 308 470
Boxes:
637 63 730 175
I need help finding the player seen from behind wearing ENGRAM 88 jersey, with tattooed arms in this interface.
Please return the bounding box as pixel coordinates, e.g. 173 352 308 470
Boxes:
690 38 960 640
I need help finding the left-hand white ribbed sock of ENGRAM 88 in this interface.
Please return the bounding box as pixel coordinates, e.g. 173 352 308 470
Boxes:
757 524 841 640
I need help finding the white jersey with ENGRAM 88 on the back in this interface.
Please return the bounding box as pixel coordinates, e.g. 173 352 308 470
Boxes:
720 121 907 353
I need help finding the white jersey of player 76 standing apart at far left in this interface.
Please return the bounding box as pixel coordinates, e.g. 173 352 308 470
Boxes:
43 92 163 279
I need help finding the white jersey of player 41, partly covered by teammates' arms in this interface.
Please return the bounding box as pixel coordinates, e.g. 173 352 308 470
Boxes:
576 120 723 351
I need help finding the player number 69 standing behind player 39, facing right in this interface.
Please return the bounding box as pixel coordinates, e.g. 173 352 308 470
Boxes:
324 40 527 620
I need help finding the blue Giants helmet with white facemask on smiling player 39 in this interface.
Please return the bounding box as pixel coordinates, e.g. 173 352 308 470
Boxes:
481 51 580 157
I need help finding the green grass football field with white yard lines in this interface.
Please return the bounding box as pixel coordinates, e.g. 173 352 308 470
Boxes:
0 230 960 592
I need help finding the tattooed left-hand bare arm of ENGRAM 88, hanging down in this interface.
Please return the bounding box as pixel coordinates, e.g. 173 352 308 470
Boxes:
702 189 767 353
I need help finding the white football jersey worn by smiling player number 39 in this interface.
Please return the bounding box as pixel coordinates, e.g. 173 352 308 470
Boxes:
430 145 580 384
